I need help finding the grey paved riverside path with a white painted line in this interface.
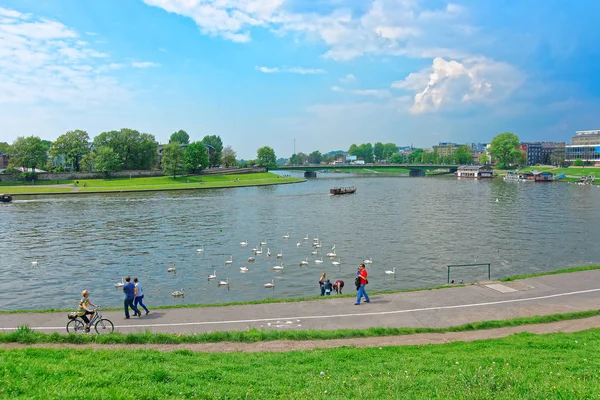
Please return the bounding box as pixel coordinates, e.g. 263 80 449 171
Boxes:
0 270 600 333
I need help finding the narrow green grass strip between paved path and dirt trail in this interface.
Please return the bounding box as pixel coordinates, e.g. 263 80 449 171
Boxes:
0 310 600 344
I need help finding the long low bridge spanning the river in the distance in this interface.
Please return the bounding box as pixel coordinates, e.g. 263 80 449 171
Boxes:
277 164 459 178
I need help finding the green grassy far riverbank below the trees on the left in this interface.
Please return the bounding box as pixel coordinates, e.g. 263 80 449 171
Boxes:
1 172 304 195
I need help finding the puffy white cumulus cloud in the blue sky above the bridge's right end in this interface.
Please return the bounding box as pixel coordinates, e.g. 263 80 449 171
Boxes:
392 57 524 113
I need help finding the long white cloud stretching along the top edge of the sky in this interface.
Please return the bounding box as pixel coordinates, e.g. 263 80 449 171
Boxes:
144 0 469 60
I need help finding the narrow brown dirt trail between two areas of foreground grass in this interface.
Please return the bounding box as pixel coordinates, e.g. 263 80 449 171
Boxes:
0 316 600 353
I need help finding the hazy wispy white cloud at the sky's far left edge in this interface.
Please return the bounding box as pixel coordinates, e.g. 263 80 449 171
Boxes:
0 8 133 108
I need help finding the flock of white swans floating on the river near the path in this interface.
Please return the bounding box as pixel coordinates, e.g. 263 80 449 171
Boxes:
115 233 396 297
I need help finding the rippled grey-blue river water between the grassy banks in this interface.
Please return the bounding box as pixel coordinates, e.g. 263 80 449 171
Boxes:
0 174 600 310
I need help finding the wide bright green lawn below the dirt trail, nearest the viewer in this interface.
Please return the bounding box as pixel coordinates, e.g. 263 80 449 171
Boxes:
0 329 600 400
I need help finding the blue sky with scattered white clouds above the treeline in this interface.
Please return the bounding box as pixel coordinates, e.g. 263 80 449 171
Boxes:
0 0 600 159
